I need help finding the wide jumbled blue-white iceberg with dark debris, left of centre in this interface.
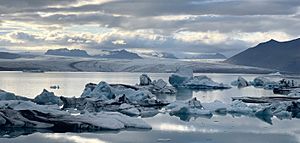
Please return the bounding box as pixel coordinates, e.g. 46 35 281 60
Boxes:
61 82 169 116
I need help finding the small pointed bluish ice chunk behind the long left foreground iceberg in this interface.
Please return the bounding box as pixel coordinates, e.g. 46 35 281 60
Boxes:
33 89 63 105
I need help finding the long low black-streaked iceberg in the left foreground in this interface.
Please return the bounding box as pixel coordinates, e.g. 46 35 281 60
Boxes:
0 100 151 132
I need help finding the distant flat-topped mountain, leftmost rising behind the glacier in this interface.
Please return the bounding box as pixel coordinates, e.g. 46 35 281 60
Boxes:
45 48 90 57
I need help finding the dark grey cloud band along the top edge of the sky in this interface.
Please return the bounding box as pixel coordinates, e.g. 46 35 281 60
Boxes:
24 0 300 17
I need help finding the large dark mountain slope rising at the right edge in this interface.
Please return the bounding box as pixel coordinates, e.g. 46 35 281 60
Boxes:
225 39 300 73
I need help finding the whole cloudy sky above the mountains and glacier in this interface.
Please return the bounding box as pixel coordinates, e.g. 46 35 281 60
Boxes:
0 0 300 56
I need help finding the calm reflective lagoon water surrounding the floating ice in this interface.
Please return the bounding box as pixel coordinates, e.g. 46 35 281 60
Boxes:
0 72 300 143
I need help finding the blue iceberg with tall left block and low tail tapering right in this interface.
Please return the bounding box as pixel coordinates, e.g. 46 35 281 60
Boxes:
169 70 231 90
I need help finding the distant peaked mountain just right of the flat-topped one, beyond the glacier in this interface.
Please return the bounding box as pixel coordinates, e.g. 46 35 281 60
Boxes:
94 49 142 59
